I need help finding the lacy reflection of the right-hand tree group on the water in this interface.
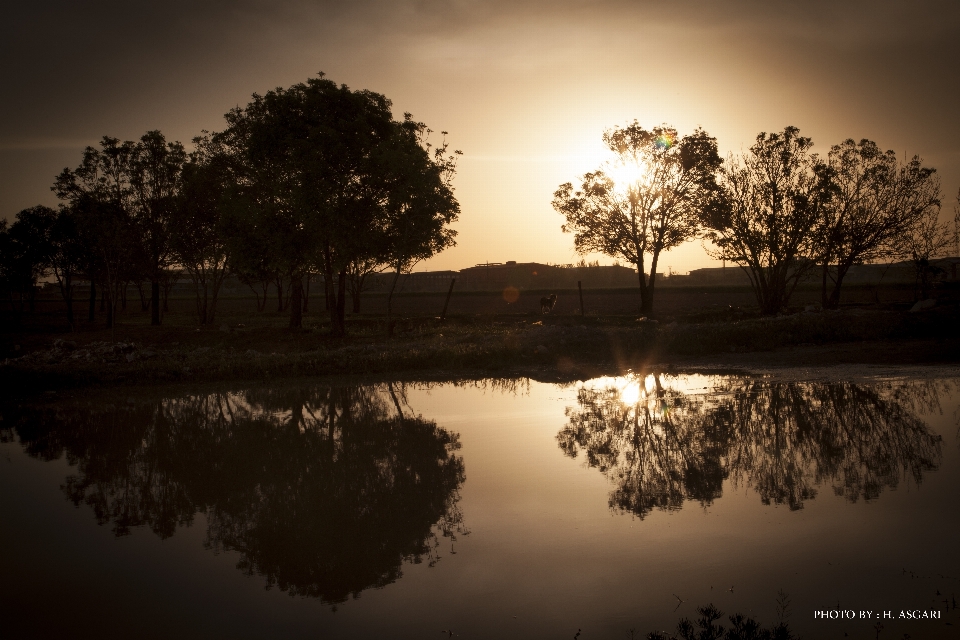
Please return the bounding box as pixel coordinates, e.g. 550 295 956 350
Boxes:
557 378 940 517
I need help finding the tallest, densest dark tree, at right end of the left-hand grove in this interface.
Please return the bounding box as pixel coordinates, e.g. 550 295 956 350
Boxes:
217 75 458 334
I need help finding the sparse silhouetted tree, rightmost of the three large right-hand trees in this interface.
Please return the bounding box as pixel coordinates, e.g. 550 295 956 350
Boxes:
816 140 940 309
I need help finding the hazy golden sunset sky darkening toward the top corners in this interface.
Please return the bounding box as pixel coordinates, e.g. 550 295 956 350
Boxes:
0 0 960 273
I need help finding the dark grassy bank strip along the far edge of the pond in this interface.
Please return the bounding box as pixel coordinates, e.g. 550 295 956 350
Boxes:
0 289 960 391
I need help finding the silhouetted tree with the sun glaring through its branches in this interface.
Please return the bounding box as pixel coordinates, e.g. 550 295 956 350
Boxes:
553 121 721 313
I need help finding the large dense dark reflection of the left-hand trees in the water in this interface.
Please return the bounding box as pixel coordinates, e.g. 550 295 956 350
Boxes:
7 387 464 602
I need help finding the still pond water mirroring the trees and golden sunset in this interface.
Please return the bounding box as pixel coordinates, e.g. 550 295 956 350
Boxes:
0 370 960 640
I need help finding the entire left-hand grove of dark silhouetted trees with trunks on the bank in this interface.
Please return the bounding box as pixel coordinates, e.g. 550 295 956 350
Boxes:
0 73 460 334
